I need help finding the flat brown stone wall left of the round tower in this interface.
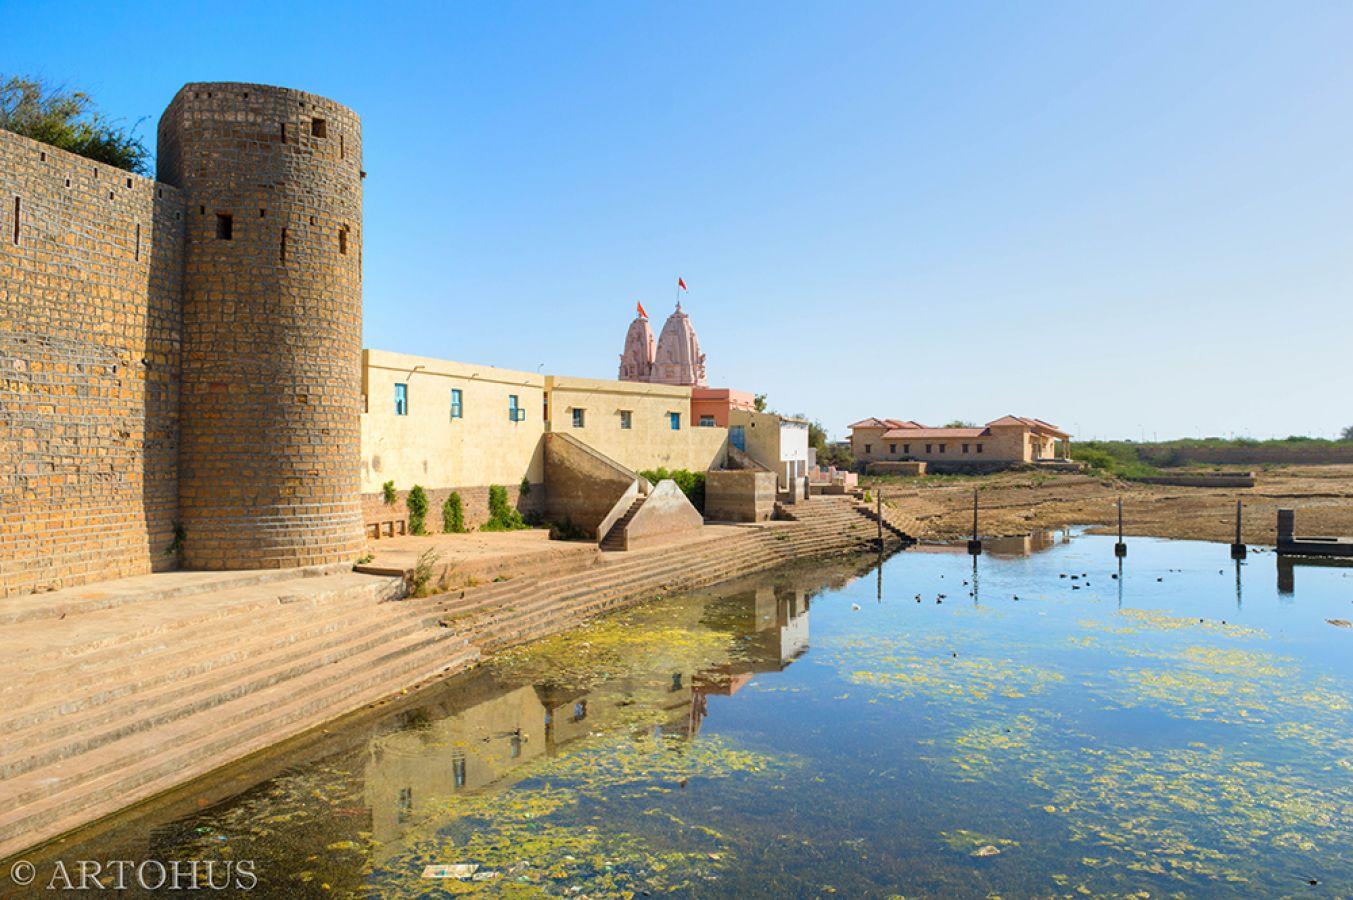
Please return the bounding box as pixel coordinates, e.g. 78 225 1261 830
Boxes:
0 131 183 595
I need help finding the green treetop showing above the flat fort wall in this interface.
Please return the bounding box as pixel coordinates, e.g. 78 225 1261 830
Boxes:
0 76 150 175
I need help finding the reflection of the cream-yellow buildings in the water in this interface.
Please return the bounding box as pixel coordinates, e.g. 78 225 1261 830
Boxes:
364 587 809 854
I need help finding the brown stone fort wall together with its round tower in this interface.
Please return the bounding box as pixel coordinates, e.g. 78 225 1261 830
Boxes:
0 83 363 597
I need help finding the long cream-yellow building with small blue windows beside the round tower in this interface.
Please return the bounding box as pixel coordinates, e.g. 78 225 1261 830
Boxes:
360 349 728 533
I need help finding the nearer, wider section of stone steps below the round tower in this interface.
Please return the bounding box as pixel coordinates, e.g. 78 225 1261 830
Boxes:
0 571 479 857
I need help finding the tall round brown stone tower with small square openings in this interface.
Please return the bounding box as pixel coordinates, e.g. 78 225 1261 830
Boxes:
157 84 364 568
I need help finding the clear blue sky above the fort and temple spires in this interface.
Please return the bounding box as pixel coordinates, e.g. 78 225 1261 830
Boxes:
0 0 1353 438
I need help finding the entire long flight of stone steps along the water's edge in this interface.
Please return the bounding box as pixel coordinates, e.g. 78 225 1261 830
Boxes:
0 497 909 858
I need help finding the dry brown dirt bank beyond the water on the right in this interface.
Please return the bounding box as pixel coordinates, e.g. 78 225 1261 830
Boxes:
861 466 1353 544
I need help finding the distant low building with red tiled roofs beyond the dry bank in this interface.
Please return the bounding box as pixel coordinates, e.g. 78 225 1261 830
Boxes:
850 415 1072 471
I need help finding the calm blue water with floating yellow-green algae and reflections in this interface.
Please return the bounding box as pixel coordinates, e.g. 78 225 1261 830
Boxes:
29 535 1353 897
